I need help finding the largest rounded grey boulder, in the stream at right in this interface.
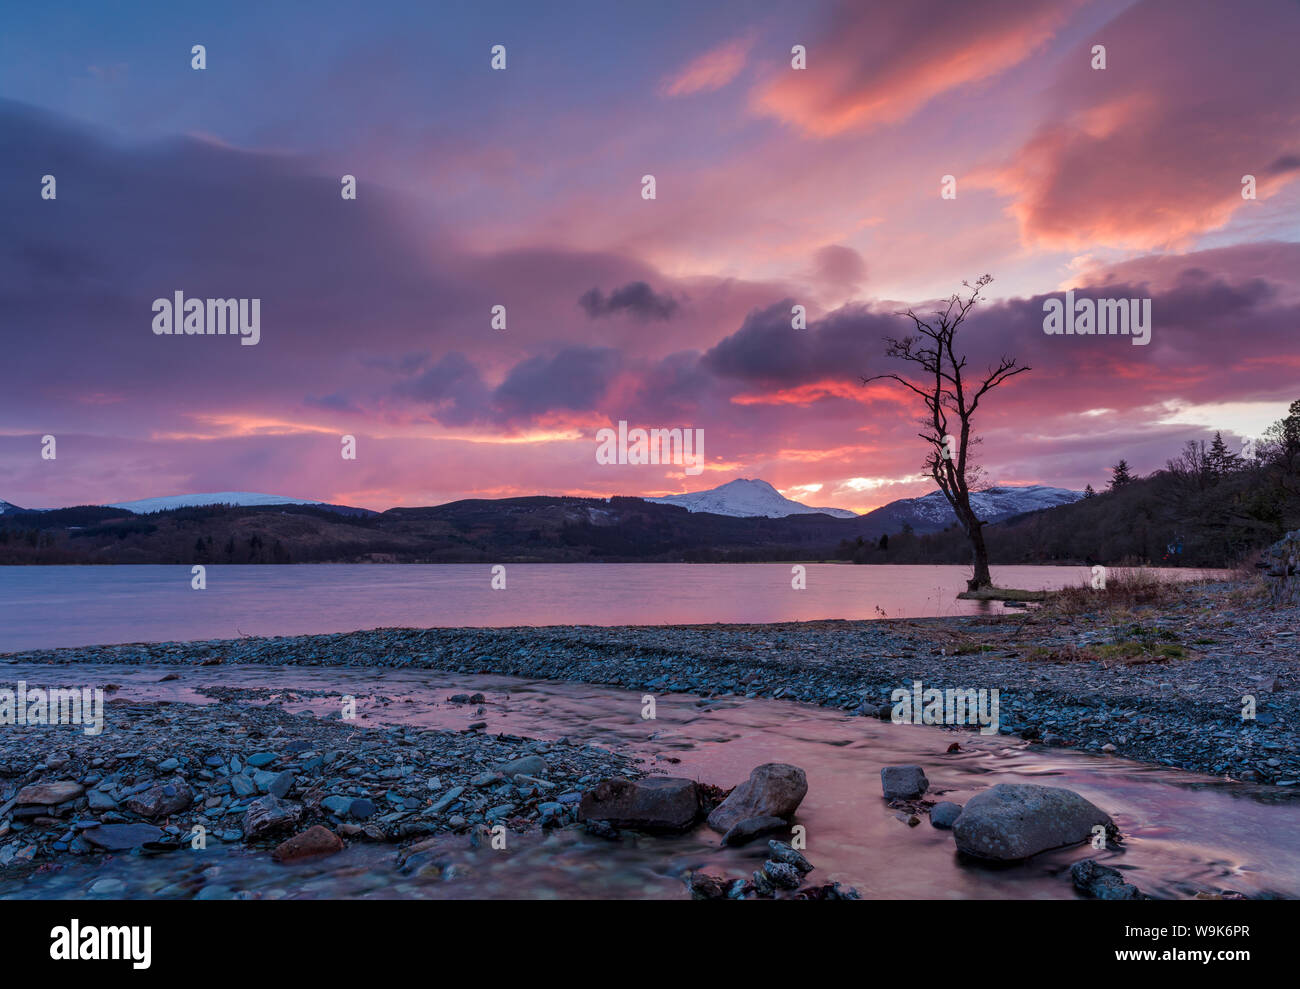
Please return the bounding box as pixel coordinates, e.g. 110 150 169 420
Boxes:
953 782 1114 862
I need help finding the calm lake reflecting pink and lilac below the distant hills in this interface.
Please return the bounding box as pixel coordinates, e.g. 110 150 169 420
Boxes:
0 563 1227 652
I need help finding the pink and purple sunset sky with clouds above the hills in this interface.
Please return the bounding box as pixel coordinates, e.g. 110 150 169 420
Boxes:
0 0 1300 512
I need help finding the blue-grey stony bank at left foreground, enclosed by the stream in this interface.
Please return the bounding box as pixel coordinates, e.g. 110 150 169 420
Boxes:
0 700 641 878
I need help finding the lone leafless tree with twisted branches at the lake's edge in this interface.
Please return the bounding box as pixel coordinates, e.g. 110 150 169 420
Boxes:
862 274 1030 591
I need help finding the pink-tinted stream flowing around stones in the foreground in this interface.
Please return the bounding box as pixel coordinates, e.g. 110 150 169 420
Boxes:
0 665 1300 899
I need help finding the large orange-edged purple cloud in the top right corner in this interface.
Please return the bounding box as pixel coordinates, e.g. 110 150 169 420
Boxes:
989 0 1300 250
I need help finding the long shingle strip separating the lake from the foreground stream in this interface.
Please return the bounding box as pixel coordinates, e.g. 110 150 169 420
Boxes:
0 582 1300 793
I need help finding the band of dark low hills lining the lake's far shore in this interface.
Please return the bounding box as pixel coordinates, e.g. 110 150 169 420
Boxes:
0 468 1300 567
